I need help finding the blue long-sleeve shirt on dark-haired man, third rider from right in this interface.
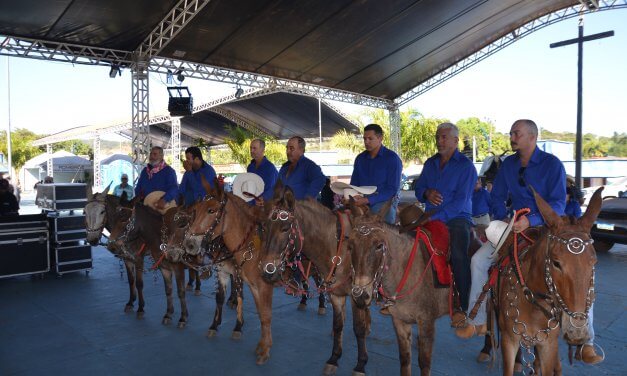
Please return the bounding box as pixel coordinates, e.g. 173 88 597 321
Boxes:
351 145 403 205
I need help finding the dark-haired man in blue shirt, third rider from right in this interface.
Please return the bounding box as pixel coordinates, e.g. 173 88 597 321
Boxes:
350 124 403 225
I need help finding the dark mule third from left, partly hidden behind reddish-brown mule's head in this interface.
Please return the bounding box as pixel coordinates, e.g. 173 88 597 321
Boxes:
166 202 244 338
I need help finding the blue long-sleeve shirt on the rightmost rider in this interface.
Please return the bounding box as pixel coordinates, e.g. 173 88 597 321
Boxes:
492 147 566 226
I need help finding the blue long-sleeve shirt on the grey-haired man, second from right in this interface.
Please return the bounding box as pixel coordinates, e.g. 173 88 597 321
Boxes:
415 150 477 222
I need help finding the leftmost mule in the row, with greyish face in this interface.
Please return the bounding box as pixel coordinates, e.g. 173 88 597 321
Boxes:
84 187 144 317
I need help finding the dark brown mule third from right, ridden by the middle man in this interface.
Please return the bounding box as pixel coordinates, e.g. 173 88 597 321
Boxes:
262 183 370 375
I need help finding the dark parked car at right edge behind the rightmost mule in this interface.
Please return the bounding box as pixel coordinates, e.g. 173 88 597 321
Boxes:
590 192 627 252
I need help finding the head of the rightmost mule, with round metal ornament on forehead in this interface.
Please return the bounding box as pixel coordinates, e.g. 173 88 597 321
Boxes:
534 188 603 345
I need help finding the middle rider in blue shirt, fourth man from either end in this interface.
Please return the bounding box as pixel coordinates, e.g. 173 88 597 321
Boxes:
279 136 326 200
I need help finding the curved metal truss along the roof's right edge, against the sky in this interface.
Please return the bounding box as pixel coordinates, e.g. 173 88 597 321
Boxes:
394 0 627 106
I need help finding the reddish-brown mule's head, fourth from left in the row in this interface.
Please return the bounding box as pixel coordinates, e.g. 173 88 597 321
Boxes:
183 175 226 255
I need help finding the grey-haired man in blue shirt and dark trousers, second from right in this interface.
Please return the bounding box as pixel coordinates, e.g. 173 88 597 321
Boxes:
415 123 477 311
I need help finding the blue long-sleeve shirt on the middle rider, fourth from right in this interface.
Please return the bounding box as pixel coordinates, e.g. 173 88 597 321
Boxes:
279 155 326 200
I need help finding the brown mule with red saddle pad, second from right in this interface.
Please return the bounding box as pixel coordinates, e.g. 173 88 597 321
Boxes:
348 208 449 375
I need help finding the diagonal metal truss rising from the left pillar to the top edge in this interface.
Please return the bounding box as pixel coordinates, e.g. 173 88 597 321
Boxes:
137 0 210 58
